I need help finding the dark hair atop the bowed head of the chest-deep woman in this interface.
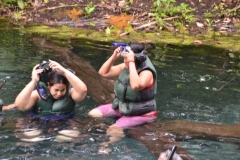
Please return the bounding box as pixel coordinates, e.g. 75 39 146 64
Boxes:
47 71 69 87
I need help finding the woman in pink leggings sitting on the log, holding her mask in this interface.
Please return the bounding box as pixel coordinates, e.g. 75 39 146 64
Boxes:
88 42 157 151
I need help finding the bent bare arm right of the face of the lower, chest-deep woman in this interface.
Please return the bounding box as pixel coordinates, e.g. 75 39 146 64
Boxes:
49 60 87 103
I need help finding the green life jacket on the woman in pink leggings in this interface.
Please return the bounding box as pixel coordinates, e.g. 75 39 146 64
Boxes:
112 57 157 116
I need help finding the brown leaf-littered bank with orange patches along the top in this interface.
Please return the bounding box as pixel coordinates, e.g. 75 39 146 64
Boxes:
0 0 240 35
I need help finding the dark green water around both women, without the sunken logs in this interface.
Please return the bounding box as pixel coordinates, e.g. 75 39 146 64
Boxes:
0 21 240 160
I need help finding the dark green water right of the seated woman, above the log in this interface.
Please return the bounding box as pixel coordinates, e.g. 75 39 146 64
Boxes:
150 46 239 123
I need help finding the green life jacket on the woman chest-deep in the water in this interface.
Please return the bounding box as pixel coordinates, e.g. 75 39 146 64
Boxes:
32 81 75 114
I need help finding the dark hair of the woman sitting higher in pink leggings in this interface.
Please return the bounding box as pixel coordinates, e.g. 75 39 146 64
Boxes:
128 42 147 67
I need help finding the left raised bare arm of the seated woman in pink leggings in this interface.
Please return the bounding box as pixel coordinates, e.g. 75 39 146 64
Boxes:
98 47 124 78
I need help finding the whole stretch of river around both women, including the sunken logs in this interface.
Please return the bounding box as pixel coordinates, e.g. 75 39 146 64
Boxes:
0 20 240 160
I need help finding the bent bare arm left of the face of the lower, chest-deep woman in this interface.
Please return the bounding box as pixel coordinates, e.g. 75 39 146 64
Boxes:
15 65 43 111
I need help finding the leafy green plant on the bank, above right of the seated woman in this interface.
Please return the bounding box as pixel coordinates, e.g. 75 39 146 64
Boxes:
151 0 194 28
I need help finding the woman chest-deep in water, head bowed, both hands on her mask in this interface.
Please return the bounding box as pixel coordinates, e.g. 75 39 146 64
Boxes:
14 60 87 117
